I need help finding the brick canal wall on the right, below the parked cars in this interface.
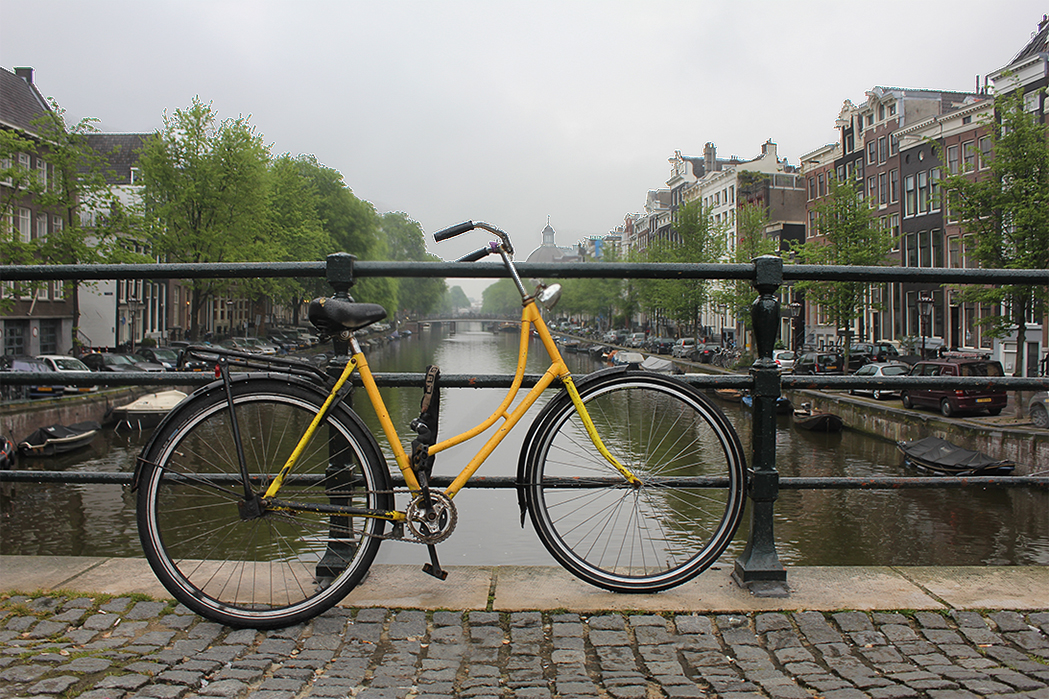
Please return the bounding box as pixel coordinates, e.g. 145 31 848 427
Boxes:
784 390 1049 475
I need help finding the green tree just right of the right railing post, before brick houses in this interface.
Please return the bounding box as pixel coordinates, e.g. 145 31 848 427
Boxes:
795 178 893 366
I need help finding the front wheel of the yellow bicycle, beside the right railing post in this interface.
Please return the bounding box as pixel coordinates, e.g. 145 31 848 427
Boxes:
525 372 747 593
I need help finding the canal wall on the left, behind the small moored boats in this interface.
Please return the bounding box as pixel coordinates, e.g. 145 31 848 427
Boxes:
0 386 150 443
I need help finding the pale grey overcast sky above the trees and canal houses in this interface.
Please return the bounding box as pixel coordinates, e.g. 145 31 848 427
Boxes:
0 0 1049 295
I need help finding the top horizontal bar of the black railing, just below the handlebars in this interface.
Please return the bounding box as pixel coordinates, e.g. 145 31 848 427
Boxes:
0 260 1049 285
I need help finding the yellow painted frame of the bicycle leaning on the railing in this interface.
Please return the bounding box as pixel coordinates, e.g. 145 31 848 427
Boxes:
262 287 641 521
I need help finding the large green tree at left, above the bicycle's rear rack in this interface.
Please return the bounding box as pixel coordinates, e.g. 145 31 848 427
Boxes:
138 99 274 338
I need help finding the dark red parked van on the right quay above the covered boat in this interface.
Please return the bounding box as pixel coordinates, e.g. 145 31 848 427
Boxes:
900 359 1009 418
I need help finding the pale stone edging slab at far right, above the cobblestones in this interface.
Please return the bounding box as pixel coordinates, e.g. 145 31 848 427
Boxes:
900 566 1049 609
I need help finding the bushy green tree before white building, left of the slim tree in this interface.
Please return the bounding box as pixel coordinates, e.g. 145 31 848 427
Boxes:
635 202 725 333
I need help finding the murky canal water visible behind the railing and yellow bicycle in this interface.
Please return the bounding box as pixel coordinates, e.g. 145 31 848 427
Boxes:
0 323 1049 566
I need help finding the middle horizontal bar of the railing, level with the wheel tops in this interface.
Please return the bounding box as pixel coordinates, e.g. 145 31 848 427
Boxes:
0 372 1049 390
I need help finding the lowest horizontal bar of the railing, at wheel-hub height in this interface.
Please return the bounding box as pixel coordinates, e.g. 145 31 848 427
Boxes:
0 470 1049 490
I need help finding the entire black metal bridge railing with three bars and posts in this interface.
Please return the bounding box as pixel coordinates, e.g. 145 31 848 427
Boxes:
0 253 1049 595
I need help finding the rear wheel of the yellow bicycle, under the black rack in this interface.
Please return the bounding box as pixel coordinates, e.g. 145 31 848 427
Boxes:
136 378 392 629
